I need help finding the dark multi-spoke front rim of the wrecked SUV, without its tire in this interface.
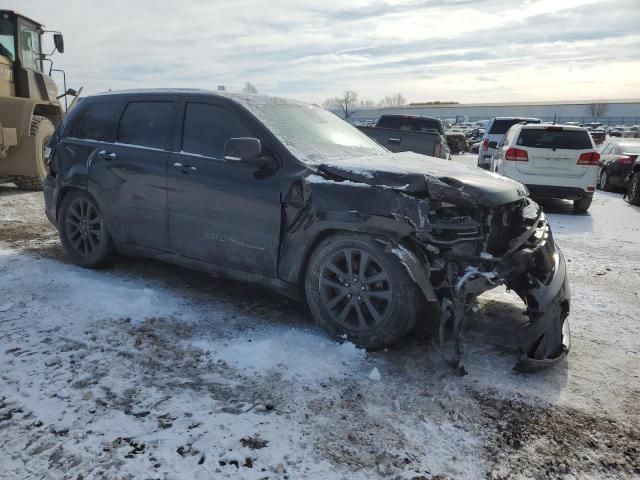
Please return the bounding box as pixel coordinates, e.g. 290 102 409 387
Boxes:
320 248 393 331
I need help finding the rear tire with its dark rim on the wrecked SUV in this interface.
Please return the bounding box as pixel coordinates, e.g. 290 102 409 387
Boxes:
58 190 113 268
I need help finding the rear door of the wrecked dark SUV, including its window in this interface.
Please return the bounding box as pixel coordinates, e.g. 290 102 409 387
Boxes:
89 97 176 251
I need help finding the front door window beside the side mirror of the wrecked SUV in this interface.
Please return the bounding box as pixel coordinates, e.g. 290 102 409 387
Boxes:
182 103 255 159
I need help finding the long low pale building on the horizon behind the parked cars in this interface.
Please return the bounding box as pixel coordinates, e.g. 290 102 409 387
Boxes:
335 99 640 125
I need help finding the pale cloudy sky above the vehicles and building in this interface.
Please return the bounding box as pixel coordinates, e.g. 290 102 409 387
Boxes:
8 0 640 102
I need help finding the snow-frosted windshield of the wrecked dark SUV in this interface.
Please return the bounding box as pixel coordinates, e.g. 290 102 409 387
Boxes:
239 97 388 165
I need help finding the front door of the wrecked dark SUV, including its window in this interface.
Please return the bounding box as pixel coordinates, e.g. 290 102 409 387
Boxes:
169 101 281 277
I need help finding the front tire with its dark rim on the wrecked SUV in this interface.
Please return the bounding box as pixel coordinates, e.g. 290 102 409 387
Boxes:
305 234 423 349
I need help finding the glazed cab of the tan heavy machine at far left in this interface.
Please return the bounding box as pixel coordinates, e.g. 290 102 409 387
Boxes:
0 10 64 104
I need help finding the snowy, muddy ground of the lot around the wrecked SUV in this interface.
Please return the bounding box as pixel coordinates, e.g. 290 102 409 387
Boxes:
0 167 640 479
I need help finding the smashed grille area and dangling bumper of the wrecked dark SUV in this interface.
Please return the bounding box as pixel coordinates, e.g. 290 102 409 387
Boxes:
416 199 570 373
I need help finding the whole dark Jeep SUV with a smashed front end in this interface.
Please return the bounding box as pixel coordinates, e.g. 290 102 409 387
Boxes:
44 90 569 371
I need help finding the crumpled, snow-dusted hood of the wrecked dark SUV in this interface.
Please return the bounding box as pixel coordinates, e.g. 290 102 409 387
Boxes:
318 152 529 207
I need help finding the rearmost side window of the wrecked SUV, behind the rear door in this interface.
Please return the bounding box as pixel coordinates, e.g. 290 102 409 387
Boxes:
65 102 122 142
